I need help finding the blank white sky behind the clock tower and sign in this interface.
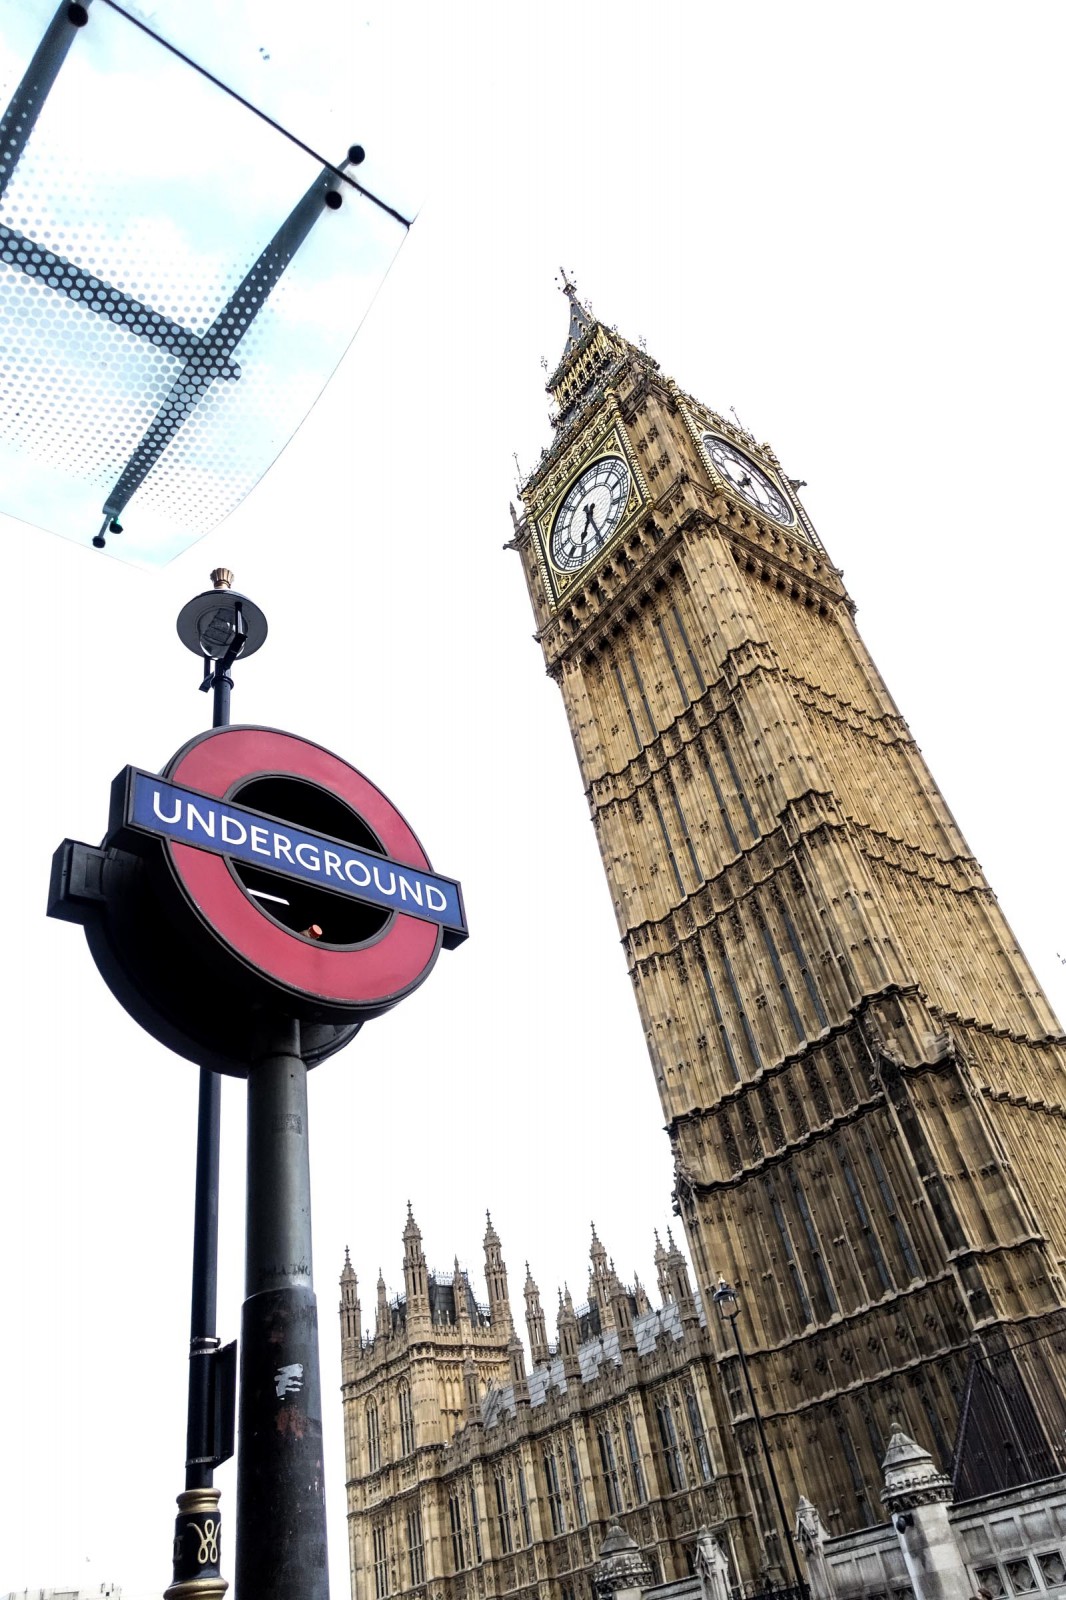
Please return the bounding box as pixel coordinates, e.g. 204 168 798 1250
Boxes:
0 0 1066 1600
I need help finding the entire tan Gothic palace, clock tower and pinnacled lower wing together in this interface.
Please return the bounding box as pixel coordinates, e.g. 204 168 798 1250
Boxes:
341 285 1066 1600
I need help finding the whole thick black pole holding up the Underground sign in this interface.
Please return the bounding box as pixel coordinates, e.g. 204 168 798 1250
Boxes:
235 1021 330 1600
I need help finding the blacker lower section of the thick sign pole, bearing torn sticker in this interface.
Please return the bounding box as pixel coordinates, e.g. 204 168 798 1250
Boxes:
235 1286 330 1600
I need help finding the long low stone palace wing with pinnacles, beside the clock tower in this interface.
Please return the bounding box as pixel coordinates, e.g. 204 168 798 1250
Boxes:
341 1214 729 1600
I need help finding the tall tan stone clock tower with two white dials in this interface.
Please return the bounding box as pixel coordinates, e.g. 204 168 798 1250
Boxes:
514 283 1066 1555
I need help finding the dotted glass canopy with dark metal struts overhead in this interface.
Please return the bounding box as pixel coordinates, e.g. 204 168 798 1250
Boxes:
0 0 419 566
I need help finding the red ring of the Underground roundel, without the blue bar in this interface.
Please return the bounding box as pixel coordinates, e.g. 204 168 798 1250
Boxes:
165 728 442 1008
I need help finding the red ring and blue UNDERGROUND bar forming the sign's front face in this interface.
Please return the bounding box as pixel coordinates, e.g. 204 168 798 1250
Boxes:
109 726 467 1016
